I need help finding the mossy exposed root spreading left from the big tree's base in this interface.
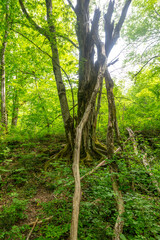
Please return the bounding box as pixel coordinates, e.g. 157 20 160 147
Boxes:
44 144 72 171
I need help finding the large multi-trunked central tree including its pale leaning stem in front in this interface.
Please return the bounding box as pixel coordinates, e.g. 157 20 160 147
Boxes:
16 0 131 240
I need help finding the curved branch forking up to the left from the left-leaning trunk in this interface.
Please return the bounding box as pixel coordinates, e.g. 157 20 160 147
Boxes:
19 0 49 38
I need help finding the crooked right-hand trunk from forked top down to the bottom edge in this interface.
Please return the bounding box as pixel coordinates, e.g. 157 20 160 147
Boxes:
104 0 131 240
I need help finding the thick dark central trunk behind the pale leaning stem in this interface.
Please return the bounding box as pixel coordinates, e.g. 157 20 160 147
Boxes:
75 0 103 158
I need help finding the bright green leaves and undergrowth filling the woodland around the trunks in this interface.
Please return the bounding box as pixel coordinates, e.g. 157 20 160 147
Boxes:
0 0 160 240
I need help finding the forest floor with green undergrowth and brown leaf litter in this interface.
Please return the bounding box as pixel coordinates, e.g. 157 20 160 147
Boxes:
0 133 160 240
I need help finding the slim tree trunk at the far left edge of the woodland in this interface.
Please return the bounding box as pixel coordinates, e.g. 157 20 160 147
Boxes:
0 3 9 131
